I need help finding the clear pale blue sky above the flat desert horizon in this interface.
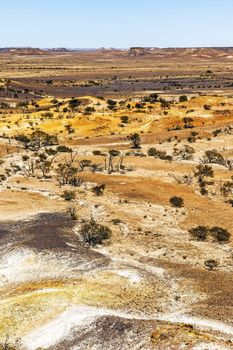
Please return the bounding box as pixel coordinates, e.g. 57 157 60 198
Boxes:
0 0 233 48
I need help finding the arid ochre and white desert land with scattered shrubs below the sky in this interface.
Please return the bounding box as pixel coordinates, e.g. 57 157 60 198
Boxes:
0 47 233 350
